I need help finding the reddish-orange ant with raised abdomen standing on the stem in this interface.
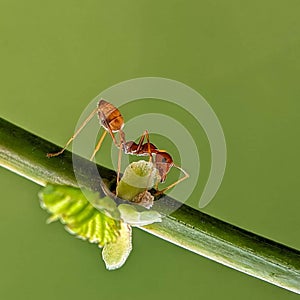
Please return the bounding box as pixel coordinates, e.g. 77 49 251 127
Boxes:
47 99 189 194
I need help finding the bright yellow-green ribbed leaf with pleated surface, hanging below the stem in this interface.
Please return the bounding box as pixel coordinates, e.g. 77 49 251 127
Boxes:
39 185 121 247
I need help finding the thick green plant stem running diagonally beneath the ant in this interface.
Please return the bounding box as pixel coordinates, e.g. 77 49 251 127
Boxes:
0 119 300 294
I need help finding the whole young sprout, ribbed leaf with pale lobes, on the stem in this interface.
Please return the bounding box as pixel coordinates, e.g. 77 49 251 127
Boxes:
39 177 161 270
